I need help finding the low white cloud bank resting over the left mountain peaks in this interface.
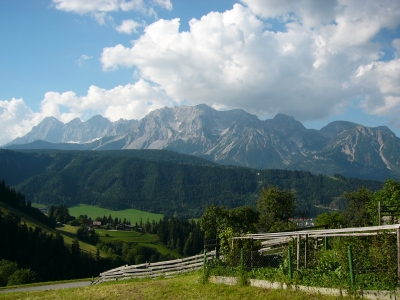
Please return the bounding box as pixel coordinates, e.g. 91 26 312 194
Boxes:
0 79 173 145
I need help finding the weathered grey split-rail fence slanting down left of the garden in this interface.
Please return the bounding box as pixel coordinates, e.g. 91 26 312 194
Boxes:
92 251 216 285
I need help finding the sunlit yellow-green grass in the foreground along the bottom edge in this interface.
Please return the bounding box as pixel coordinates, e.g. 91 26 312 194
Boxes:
0 273 351 300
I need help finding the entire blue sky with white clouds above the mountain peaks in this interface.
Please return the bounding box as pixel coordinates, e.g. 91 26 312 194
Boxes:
0 0 400 145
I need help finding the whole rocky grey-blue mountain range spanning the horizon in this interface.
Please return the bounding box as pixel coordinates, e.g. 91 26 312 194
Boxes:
3 104 400 180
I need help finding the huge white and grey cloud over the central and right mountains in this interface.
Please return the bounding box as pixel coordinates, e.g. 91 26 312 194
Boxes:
101 0 400 121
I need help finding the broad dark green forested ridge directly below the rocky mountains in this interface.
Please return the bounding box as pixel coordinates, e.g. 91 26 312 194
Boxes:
0 150 382 217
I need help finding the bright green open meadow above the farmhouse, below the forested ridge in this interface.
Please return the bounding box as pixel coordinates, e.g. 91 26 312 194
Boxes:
69 204 163 224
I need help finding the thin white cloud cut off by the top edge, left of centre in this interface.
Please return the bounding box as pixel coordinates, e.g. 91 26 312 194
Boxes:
53 0 172 25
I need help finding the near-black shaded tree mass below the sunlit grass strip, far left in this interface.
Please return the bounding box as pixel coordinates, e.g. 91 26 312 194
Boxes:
0 211 108 281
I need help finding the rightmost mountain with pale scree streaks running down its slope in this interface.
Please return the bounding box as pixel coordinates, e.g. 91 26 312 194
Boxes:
291 125 400 180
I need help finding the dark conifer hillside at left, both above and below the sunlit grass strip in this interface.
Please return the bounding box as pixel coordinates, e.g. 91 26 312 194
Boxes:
0 181 108 286
